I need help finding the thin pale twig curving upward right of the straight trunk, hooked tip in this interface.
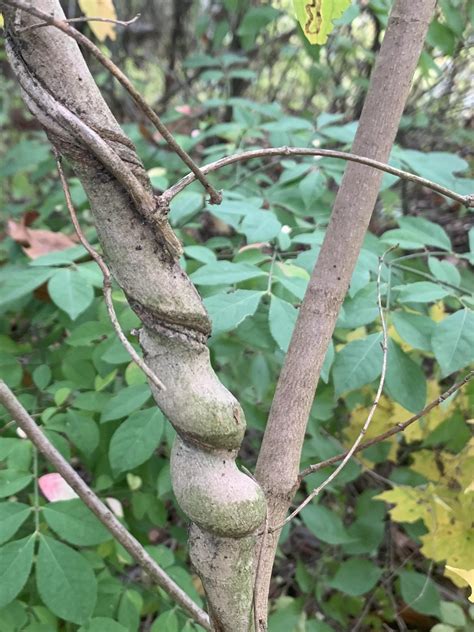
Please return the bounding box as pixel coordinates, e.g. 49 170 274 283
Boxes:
270 246 396 533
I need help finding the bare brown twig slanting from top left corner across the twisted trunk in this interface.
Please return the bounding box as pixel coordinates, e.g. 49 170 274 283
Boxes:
3 0 222 204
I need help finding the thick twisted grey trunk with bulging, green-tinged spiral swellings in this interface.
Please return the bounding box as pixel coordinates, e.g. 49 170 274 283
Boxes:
0 0 266 632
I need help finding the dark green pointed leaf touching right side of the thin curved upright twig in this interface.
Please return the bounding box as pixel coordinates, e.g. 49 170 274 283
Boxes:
384 339 426 413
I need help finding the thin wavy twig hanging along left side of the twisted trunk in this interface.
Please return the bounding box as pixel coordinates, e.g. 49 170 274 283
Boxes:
55 152 166 391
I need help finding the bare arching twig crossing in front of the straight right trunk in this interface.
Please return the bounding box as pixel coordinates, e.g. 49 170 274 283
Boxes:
163 147 474 207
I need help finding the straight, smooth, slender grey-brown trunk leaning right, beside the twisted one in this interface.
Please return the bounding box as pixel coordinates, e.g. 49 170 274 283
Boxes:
256 0 435 629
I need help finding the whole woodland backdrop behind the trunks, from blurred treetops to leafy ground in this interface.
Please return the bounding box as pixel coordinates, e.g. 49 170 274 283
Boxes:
0 0 474 632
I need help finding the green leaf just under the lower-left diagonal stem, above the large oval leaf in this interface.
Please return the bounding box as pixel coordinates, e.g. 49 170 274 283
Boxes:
42 498 112 546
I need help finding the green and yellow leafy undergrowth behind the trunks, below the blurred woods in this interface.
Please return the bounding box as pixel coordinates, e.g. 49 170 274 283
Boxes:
0 14 474 632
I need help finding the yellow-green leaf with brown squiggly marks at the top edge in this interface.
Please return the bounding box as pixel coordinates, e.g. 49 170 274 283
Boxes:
293 0 351 44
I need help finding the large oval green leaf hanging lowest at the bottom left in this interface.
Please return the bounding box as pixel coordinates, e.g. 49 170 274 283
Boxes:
36 535 97 624
